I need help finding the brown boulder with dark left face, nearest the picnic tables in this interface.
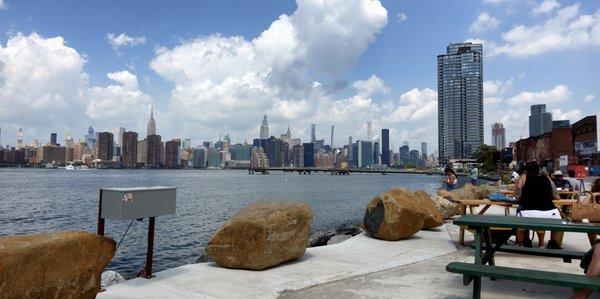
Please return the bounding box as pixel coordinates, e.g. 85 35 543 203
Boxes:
363 192 427 241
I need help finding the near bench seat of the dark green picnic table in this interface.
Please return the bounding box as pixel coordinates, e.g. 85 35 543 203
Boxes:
446 262 600 290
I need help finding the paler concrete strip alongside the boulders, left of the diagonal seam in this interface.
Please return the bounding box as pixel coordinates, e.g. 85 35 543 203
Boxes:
98 226 456 299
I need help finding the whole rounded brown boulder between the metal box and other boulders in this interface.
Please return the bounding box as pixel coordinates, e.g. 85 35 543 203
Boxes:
206 201 312 270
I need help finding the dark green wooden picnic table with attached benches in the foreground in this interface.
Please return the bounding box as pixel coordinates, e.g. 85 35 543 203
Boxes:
446 215 600 298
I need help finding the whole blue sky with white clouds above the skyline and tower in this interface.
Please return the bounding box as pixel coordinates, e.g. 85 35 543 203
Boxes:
0 0 600 154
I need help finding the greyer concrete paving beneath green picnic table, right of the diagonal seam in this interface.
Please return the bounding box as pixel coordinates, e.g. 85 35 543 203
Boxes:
282 218 600 299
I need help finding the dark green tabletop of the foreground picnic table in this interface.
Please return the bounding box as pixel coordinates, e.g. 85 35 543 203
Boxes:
454 215 600 234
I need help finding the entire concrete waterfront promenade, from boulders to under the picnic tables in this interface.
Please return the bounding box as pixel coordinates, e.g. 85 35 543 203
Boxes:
98 209 597 298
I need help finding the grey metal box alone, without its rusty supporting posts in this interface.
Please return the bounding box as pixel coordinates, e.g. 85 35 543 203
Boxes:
100 187 177 220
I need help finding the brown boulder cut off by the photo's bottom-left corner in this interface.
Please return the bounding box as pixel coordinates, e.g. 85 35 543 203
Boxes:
0 231 116 298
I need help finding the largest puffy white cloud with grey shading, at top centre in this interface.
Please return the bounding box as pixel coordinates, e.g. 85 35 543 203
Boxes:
150 0 389 141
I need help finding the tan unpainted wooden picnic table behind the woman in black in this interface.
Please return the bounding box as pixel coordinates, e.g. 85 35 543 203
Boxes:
457 199 577 245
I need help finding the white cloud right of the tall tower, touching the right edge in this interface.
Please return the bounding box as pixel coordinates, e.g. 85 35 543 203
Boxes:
487 4 600 57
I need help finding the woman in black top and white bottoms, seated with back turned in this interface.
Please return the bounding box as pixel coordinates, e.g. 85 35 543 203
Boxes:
515 162 562 249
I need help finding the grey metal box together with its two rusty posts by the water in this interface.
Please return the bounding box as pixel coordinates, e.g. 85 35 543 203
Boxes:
98 187 177 278
